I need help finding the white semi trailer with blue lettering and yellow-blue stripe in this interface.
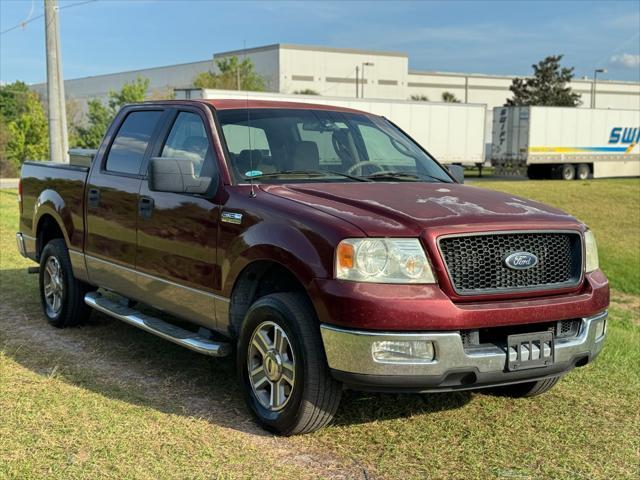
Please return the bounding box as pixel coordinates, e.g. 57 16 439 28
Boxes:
491 107 640 180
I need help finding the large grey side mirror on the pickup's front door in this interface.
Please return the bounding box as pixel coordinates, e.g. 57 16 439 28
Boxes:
148 157 217 194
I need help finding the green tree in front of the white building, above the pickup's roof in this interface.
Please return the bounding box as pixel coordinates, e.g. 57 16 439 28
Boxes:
193 56 264 92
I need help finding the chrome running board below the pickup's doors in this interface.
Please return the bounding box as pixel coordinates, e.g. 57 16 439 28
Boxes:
84 292 231 357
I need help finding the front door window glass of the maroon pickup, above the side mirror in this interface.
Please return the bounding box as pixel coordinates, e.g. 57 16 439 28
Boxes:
160 112 213 176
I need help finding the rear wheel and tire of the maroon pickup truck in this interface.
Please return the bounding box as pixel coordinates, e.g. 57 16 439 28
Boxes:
39 238 91 328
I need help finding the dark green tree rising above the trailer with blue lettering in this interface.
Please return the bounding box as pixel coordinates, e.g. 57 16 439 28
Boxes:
506 55 582 107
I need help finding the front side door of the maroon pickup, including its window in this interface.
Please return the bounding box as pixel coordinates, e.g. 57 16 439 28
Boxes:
136 108 220 329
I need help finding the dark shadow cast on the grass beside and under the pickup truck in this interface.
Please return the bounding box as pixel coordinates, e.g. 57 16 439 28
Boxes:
0 269 471 435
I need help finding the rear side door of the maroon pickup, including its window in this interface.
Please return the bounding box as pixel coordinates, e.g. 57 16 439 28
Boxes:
85 106 165 298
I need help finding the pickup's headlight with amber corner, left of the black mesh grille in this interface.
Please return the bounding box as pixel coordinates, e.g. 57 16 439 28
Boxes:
336 238 436 283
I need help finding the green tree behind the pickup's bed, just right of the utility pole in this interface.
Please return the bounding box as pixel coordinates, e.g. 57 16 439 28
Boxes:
72 77 149 148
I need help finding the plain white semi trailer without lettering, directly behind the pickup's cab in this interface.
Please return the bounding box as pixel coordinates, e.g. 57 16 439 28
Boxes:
175 89 486 165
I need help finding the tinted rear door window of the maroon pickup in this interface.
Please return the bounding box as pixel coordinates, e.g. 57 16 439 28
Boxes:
105 110 162 175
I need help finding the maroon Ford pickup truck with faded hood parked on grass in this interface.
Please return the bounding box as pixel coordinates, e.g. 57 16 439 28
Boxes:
17 100 609 435
